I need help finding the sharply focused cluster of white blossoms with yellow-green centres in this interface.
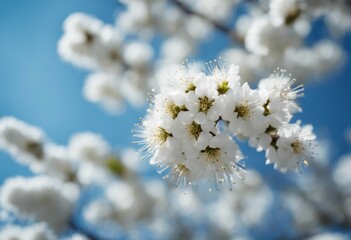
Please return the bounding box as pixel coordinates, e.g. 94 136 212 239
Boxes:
136 61 315 189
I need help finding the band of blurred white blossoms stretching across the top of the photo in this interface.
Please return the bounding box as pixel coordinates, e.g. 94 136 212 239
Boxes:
58 0 351 113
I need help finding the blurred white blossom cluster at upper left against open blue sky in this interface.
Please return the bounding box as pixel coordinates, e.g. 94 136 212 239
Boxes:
58 13 153 113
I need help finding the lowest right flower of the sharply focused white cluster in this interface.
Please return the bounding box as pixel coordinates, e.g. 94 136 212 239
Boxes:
266 124 316 172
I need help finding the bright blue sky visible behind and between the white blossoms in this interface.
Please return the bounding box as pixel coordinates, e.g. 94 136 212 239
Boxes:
0 0 351 183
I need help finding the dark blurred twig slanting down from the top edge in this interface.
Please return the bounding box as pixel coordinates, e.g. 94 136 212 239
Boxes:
170 0 244 46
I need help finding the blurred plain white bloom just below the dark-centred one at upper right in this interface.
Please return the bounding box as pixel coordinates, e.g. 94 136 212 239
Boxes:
245 16 301 56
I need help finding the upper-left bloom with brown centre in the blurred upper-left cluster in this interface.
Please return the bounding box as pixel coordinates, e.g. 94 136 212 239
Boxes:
58 13 123 72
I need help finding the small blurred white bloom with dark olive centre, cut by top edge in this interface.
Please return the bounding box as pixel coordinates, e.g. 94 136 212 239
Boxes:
269 0 301 26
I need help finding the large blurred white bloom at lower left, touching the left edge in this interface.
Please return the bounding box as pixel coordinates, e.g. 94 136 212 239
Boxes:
0 176 73 231
